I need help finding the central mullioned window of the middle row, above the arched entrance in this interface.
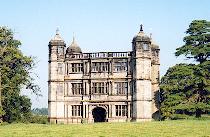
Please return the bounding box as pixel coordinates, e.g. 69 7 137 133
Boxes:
92 82 107 94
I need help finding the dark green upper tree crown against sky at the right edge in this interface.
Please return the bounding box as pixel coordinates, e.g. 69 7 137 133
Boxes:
175 20 210 63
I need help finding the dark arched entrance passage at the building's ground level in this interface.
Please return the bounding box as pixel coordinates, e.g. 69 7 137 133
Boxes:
92 107 106 122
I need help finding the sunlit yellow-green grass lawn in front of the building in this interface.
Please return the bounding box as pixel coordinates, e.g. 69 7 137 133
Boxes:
0 120 210 137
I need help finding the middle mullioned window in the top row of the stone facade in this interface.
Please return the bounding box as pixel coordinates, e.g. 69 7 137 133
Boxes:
92 62 108 72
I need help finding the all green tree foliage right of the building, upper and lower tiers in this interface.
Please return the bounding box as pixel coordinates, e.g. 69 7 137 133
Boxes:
161 20 210 118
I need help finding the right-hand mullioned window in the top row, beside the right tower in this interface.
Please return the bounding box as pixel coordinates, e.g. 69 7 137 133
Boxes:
114 60 127 72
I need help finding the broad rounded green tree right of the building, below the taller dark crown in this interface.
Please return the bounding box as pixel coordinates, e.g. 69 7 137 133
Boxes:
161 64 210 118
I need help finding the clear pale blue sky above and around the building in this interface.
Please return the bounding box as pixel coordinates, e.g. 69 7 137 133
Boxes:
0 0 210 107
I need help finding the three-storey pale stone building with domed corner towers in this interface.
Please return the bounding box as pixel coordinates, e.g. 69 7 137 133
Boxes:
48 25 160 124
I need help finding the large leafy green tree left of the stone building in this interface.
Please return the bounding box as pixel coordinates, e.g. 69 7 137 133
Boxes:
0 27 40 122
